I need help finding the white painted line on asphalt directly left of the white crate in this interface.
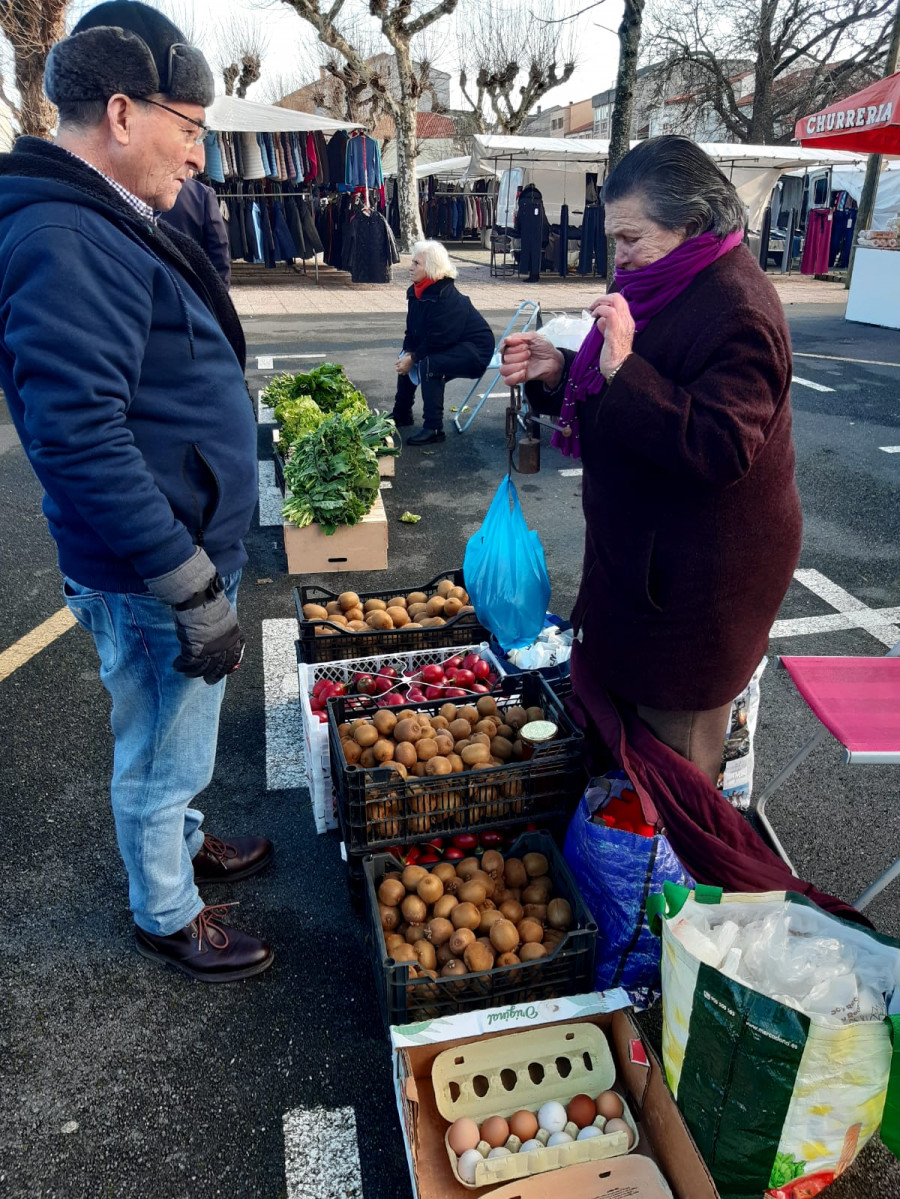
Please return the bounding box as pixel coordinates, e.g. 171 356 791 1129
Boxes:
262 619 312 796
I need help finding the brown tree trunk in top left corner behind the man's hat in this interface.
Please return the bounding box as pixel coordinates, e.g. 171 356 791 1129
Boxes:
0 0 68 138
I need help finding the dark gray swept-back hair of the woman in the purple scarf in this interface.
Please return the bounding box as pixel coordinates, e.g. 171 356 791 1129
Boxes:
603 133 745 237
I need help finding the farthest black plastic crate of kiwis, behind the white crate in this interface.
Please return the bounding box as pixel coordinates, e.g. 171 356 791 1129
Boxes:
294 571 490 662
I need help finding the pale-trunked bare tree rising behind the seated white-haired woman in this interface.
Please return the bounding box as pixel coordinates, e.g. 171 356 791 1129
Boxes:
274 0 459 251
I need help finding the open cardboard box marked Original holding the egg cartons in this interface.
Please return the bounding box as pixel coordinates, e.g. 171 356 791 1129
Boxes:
391 990 719 1199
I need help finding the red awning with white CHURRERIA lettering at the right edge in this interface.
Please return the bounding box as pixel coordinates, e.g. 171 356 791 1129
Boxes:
793 71 900 153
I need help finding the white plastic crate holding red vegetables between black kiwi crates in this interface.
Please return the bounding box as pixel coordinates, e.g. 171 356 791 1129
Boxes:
297 641 507 833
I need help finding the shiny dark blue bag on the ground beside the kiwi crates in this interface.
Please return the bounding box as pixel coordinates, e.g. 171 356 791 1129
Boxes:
563 771 694 1007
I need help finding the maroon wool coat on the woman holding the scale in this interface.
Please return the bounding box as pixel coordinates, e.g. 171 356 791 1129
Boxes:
527 246 802 711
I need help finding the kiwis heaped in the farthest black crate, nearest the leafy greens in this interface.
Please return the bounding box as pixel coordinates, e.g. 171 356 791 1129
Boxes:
303 579 475 637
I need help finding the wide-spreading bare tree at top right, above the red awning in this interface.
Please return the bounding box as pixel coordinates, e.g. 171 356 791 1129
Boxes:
647 0 896 144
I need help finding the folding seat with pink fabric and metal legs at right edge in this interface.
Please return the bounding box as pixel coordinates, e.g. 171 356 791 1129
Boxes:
753 641 900 911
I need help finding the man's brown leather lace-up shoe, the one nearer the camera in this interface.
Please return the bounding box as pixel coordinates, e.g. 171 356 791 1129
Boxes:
134 904 274 982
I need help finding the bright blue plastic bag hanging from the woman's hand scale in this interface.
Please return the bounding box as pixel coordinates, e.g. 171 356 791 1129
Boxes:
463 475 550 650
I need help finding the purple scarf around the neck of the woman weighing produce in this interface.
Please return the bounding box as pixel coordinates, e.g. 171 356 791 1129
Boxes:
550 229 743 458
